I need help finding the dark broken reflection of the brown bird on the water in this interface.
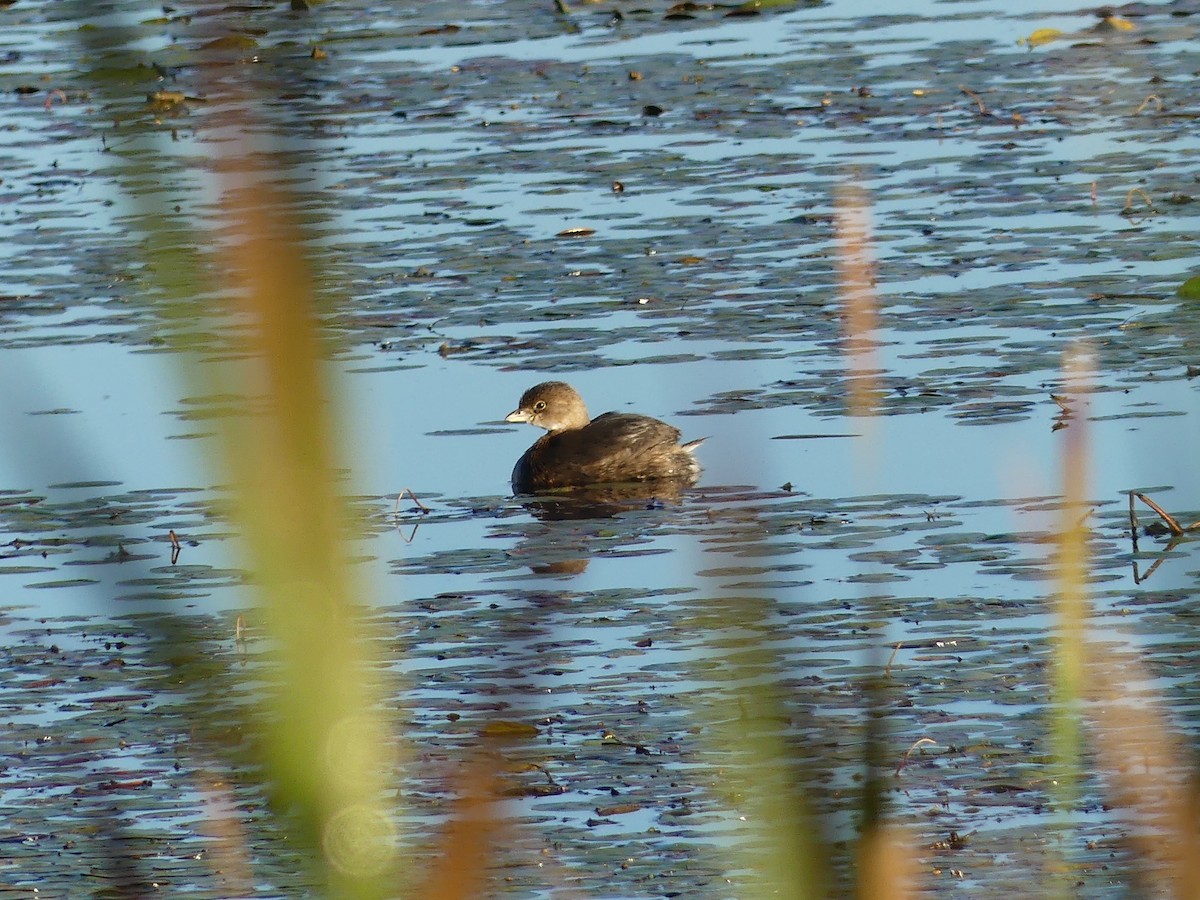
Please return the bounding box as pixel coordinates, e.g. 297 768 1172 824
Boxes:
512 481 686 576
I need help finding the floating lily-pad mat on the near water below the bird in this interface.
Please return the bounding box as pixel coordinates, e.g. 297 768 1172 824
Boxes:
0 490 1200 896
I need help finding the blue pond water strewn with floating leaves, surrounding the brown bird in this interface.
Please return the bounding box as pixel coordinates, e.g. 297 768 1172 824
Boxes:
0 0 1200 896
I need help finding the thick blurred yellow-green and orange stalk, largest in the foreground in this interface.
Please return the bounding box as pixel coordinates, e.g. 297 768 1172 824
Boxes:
218 135 397 898
